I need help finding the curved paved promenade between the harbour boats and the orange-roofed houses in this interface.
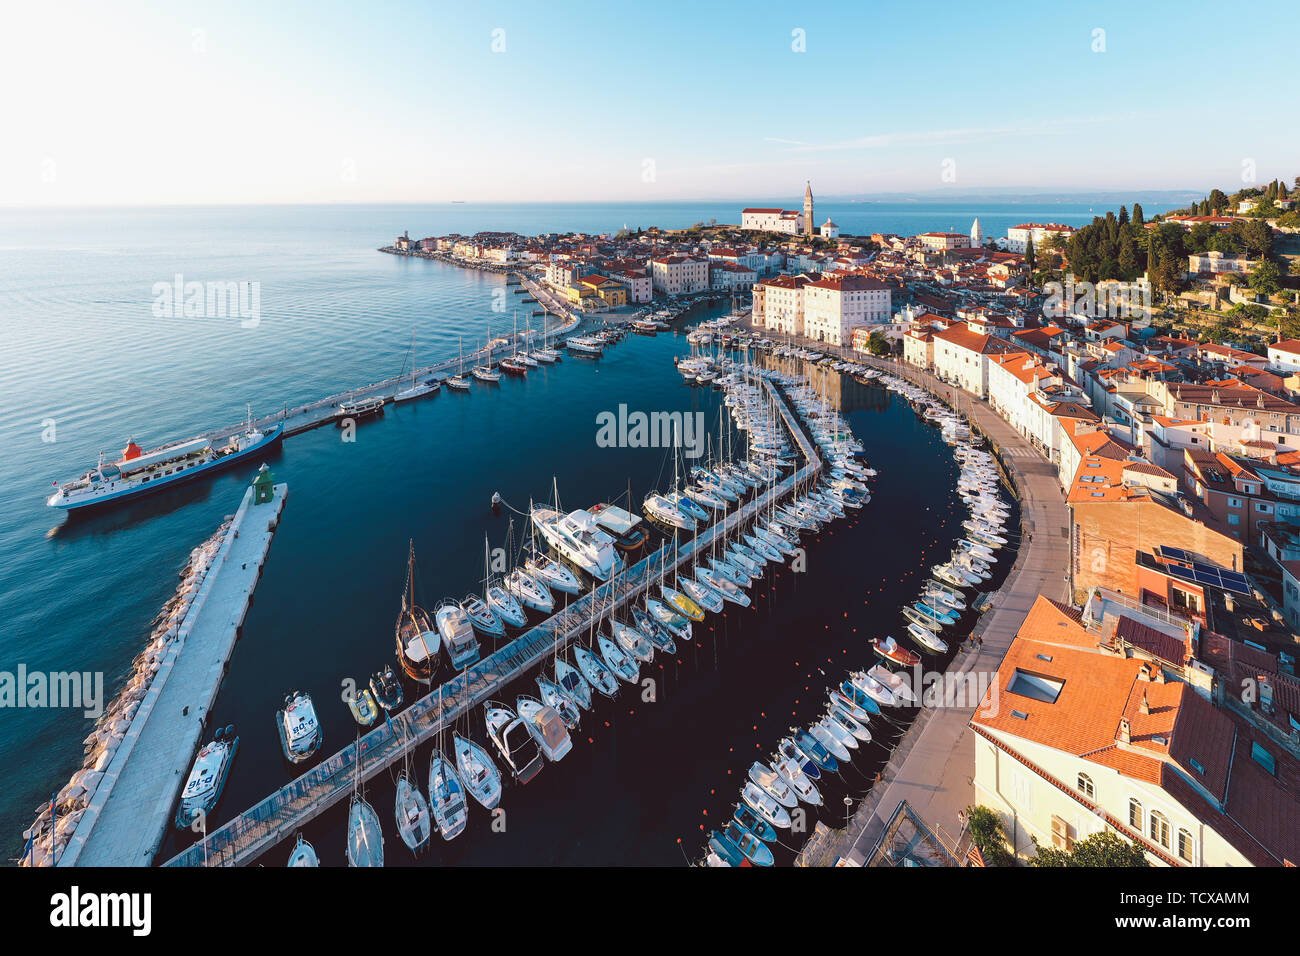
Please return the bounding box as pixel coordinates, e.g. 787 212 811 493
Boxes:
828 355 1070 865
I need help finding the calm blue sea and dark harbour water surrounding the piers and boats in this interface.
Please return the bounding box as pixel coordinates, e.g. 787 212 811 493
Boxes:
0 204 1034 864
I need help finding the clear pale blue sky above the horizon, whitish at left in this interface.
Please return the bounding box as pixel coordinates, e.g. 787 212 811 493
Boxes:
0 0 1300 204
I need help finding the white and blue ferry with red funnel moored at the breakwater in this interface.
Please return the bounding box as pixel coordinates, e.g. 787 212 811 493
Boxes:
46 414 283 511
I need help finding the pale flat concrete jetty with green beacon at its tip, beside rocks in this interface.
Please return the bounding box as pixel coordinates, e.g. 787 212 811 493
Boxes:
57 479 289 866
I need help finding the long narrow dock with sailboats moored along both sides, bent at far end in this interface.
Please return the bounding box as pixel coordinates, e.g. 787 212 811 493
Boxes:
165 378 822 866
